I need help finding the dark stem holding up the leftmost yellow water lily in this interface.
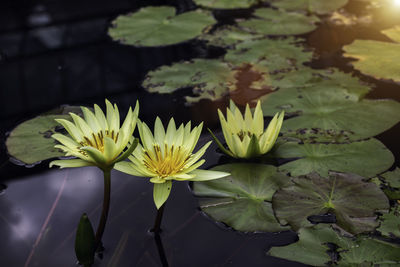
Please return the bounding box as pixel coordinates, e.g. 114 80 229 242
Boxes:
95 169 111 250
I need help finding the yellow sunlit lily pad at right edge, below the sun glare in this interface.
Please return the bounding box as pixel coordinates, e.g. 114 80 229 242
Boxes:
343 27 400 82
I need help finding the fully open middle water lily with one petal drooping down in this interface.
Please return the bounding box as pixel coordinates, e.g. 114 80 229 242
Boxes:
115 117 229 209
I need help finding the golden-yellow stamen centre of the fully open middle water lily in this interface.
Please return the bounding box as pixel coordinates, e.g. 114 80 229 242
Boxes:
143 144 192 178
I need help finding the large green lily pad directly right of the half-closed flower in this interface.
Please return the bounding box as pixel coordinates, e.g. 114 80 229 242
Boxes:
262 83 400 142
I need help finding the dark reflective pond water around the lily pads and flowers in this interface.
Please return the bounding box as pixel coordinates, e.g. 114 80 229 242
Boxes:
0 0 400 266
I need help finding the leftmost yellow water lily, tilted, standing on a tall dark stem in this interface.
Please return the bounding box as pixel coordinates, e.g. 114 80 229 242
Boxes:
50 100 139 171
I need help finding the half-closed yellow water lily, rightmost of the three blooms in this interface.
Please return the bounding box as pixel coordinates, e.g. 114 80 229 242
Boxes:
210 100 285 158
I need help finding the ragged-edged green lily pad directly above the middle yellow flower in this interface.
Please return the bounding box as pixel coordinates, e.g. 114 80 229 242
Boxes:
143 59 235 102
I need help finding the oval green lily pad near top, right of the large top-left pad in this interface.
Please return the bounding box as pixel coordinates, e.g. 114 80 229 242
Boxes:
238 8 320 35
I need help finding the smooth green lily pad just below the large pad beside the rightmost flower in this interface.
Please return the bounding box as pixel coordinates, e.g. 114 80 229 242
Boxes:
275 139 394 177
